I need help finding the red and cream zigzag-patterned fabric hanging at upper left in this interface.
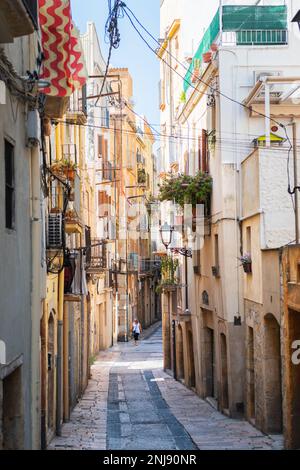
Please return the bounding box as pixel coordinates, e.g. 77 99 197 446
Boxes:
39 0 87 97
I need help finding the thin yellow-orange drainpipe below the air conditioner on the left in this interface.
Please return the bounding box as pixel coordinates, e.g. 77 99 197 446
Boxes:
56 270 65 436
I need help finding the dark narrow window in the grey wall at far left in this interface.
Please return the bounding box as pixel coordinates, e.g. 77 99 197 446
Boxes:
4 140 15 229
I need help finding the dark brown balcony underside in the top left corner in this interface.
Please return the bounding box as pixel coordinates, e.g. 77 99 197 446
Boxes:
0 0 38 43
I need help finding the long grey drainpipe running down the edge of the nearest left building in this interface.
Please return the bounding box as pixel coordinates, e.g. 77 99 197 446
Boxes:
30 134 42 449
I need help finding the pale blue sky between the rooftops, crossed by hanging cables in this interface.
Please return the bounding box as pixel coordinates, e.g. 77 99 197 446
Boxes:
71 0 160 129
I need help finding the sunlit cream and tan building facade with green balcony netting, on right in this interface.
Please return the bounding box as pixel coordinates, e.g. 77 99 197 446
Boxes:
158 0 300 442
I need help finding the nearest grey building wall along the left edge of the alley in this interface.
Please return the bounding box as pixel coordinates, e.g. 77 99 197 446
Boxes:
0 1 45 449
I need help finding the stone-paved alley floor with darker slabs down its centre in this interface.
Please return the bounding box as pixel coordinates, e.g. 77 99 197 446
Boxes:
49 328 283 450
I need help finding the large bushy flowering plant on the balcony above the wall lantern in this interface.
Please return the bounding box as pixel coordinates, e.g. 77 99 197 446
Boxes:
159 171 212 207
